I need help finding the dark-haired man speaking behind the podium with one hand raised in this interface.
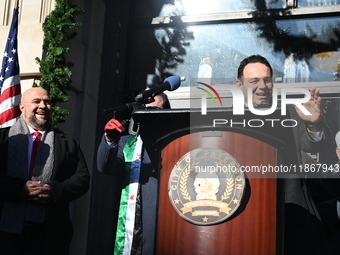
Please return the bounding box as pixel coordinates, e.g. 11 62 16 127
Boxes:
236 55 331 255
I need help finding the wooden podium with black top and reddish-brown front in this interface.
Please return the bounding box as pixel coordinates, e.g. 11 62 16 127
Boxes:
133 109 292 255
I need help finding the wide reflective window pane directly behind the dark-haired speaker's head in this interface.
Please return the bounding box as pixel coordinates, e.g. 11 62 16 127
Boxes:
131 17 340 86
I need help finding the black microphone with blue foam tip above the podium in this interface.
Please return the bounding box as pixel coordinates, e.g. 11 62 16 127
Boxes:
135 76 181 102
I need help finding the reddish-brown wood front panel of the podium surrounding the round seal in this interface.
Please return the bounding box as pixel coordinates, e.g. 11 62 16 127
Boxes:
156 132 279 255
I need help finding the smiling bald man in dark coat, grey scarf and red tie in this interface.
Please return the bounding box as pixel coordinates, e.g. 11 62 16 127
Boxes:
0 87 90 255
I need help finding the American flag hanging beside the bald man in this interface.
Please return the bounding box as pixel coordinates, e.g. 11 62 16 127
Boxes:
0 8 21 128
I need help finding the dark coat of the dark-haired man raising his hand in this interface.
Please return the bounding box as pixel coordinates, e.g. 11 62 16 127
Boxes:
284 106 332 255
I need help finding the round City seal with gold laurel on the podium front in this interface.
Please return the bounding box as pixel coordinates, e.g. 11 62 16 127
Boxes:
168 148 246 225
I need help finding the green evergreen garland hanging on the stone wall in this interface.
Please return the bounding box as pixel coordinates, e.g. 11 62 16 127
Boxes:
36 0 83 125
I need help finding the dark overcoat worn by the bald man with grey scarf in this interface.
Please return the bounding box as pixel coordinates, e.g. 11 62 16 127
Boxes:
0 128 90 254
